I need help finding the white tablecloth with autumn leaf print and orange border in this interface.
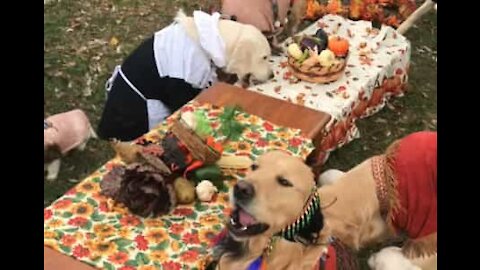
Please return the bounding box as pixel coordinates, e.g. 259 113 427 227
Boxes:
249 15 411 159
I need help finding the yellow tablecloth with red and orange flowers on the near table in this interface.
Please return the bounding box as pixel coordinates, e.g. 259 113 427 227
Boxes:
44 102 313 270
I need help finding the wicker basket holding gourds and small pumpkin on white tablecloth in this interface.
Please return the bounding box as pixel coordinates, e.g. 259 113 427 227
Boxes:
288 56 347 83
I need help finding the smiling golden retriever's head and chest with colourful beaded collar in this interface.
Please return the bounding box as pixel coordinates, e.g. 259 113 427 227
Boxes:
214 151 328 270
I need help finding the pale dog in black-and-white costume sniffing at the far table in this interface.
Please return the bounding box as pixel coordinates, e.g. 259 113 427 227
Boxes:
98 11 274 141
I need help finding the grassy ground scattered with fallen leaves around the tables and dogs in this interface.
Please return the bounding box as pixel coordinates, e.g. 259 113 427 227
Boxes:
44 0 437 267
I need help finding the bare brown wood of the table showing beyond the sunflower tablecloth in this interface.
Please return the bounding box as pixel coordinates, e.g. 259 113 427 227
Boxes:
44 83 330 270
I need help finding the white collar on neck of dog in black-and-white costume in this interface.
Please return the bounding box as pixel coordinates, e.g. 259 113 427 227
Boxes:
193 10 227 68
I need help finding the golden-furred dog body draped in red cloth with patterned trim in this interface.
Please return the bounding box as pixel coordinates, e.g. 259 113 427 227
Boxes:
318 132 437 270
